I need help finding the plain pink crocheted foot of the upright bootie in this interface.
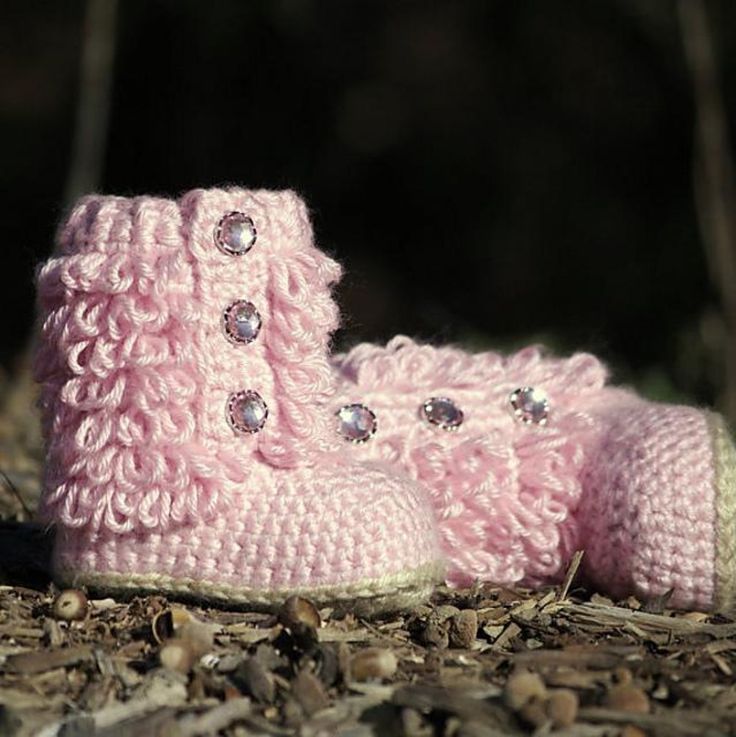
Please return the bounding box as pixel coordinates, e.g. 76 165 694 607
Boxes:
50 459 443 606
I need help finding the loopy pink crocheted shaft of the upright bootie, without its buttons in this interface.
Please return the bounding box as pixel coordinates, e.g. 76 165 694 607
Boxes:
34 190 340 533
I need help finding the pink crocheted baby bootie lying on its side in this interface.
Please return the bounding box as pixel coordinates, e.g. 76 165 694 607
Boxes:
334 336 736 610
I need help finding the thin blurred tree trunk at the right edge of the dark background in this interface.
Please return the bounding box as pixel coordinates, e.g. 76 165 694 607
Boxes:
677 0 736 423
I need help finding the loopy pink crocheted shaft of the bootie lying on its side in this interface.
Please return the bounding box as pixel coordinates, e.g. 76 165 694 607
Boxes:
335 336 606 585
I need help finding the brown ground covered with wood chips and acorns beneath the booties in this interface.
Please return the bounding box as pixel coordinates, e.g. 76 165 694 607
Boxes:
0 364 736 737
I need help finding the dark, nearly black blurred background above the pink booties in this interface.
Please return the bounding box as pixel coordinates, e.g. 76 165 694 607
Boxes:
0 0 736 418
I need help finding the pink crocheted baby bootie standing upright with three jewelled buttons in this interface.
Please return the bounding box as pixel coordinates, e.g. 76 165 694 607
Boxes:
35 189 442 614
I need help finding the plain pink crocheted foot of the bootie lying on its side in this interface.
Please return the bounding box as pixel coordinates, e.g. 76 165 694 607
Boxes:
575 389 720 609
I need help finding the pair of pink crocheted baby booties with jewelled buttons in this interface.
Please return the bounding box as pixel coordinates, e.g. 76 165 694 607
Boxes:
35 188 736 615
